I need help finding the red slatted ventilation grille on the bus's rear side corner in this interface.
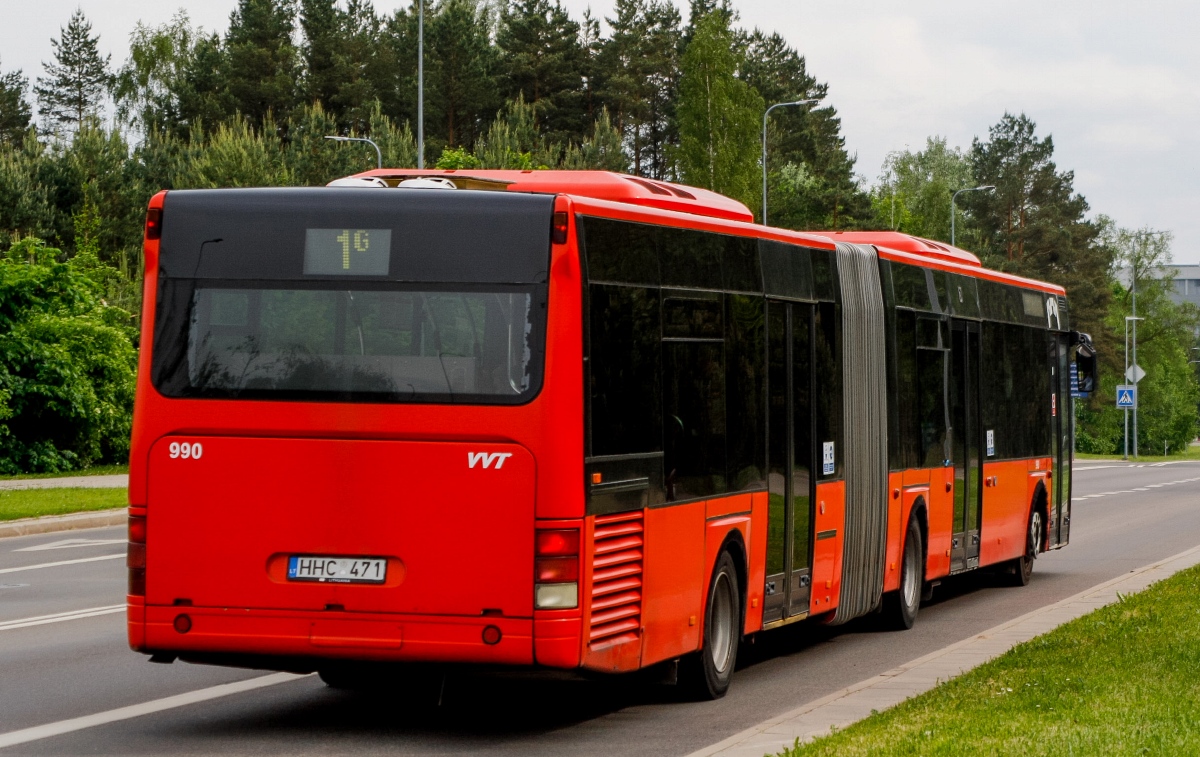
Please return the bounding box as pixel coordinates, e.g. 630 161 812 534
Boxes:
588 511 643 650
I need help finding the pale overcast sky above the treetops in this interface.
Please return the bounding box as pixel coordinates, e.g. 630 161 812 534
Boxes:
0 0 1200 263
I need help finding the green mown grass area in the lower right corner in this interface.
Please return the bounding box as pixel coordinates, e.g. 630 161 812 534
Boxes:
779 567 1200 757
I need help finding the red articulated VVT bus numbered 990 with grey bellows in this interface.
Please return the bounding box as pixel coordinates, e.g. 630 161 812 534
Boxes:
128 170 1094 697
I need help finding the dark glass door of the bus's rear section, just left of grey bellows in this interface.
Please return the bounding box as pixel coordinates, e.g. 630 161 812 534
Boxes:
763 300 815 623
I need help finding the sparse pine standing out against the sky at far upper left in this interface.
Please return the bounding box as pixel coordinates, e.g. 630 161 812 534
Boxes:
34 10 112 131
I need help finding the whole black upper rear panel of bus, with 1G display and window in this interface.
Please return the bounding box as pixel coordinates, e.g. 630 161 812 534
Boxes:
151 187 554 404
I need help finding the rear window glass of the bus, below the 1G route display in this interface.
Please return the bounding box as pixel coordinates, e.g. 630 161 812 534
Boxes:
154 282 540 404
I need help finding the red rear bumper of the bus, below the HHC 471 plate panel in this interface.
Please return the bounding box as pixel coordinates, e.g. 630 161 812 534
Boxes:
141 606 544 666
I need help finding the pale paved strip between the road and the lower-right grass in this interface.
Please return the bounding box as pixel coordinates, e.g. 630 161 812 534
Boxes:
688 547 1200 757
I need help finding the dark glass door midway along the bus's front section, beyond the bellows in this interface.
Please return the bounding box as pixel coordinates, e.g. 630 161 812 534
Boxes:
949 320 983 572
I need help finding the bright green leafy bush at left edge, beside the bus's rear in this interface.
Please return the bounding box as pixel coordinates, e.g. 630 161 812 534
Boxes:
0 239 137 474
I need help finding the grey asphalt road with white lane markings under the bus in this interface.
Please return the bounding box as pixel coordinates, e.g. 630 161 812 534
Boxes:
0 462 1200 757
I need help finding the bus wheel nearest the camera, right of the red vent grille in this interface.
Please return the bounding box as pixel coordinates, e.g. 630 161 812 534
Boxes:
679 552 742 699
